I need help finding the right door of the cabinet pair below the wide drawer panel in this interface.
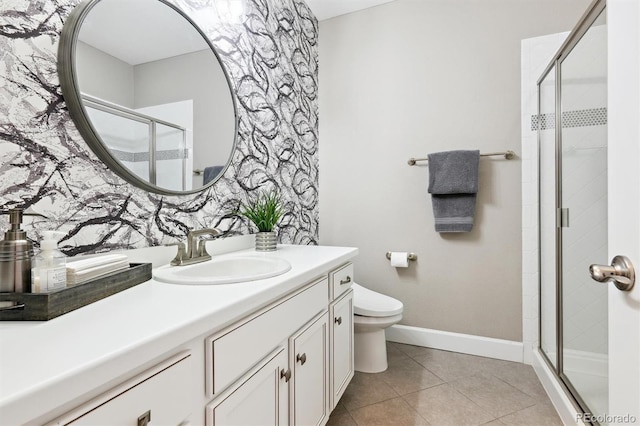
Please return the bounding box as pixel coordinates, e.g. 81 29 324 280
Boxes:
289 311 329 426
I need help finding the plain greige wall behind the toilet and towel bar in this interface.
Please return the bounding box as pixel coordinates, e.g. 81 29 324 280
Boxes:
319 0 588 341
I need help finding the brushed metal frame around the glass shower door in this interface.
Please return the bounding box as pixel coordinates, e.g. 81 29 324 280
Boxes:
536 0 607 420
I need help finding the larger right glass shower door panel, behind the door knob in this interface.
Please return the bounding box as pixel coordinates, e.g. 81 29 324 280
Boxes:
557 7 609 415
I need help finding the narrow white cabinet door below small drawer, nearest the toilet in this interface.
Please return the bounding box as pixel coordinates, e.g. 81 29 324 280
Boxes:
329 290 353 409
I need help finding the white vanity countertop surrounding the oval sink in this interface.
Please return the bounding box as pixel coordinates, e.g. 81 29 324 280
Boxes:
0 241 358 425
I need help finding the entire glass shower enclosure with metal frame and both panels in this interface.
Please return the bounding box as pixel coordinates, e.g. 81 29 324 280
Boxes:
533 1 609 416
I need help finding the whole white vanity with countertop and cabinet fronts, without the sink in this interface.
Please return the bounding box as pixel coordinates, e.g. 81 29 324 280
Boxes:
0 246 357 426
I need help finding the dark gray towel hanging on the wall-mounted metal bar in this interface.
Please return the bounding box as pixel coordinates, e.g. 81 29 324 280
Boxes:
428 150 480 232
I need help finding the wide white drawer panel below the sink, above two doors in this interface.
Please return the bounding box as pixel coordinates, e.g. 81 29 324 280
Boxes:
206 278 328 397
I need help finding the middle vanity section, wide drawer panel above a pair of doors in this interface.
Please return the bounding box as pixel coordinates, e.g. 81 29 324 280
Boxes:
205 278 329 426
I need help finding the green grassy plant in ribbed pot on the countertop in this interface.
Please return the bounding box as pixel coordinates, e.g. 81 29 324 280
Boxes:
240 191 284 251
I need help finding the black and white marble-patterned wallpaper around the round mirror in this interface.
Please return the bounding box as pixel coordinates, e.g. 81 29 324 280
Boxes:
0 0 319 255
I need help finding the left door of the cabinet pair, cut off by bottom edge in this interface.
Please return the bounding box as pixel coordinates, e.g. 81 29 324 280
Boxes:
207 347 291 426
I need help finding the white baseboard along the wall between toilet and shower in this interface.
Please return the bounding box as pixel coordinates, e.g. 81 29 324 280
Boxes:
386 325 523 362
